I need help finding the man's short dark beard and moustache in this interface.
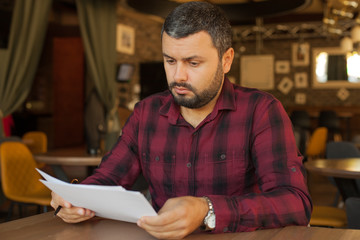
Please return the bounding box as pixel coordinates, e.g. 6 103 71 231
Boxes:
169 63 224 109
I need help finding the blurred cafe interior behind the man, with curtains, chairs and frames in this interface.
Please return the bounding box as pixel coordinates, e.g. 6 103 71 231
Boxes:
0 0 360 236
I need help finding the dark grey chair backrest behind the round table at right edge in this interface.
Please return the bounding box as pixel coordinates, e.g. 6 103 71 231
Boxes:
326 141 360 159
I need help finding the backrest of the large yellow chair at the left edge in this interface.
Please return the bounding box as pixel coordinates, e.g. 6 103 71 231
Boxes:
0 142 44 200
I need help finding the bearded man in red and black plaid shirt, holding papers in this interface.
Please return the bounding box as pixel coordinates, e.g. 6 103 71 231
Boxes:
52 2 312 239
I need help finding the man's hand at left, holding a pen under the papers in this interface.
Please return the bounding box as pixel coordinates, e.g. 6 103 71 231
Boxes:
50 192 95 223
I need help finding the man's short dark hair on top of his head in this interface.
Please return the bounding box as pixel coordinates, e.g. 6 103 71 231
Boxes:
161 2 232 59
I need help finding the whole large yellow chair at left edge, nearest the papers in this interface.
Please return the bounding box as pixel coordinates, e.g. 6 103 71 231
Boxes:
0 142 51 219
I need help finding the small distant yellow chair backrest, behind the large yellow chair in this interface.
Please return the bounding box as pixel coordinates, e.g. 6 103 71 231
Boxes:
22 131 47 154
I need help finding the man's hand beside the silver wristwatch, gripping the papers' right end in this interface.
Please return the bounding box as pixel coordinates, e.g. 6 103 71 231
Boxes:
137 196 209 239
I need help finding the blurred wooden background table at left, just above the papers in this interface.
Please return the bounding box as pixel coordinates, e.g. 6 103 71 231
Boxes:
34 147 102 181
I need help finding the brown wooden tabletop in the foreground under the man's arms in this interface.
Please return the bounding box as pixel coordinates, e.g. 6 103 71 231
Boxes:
0 212 360 240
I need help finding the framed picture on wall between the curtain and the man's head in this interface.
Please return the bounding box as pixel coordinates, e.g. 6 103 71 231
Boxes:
116 24 135 55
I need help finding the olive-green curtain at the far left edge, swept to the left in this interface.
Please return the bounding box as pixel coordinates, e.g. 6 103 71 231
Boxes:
0 0 52 137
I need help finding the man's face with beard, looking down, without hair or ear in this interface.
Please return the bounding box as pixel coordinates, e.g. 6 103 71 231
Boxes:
162 32 224 108
